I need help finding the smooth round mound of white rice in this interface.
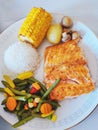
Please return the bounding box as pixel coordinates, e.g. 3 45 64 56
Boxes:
4 42 39 73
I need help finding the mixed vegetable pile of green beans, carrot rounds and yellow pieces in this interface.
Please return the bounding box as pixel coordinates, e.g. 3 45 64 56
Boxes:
0 71 60 128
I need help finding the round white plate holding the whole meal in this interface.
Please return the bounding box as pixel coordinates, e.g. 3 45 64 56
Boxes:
0 14 98 130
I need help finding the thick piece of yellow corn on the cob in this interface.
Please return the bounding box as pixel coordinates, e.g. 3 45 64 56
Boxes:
18 8 52 47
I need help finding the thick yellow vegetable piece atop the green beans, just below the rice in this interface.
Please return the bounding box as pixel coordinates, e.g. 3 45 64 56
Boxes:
17 71 33 80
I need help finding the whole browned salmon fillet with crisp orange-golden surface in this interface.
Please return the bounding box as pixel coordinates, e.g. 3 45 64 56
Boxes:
44 40 95 100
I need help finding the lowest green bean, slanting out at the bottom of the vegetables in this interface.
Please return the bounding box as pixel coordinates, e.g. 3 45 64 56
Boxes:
12 113 41 128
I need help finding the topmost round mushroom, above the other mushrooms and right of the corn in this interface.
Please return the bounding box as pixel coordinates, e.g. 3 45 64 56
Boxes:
61 16 73 28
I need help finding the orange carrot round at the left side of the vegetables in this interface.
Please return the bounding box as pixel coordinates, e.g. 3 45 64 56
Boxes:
6 97 17 111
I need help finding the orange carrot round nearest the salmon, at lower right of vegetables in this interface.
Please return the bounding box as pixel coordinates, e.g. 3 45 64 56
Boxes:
40 103 52 114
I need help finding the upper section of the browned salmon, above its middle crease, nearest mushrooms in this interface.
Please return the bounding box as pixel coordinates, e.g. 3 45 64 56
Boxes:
45 40 86 67
